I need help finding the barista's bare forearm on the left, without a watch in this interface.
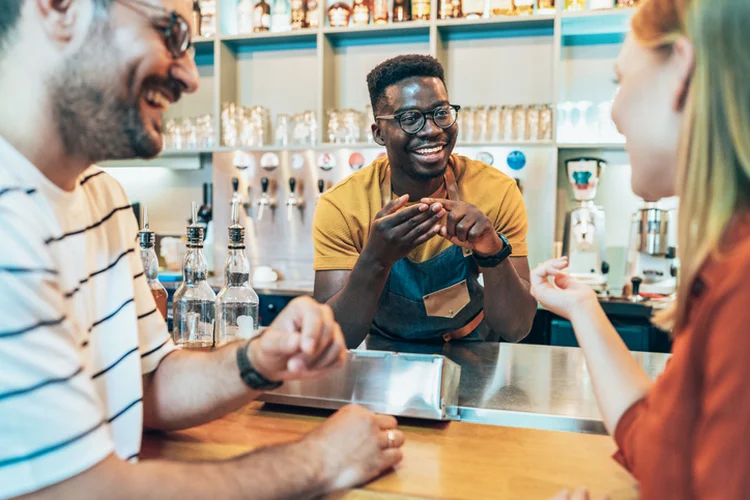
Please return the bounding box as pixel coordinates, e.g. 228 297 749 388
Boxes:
327 253 391 349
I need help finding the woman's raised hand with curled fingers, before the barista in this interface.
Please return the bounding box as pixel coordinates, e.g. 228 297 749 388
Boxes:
531 257 598 320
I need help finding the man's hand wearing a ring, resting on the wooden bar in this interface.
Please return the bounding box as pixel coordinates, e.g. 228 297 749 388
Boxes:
302 405 404 491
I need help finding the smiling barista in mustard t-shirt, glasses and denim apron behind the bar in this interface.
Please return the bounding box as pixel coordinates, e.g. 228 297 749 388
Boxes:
313 55 536 347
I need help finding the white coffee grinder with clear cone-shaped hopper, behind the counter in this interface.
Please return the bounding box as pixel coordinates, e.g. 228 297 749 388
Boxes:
563 158 609 294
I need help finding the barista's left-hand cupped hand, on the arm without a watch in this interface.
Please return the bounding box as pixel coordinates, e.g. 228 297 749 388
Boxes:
362 195 446 267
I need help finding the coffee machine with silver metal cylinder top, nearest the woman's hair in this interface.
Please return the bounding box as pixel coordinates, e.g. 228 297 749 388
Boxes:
627 202 677 301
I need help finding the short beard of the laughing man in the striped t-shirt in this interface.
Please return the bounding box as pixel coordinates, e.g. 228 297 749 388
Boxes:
50 20 160 163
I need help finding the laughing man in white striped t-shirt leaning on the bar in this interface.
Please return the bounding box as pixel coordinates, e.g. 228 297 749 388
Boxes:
0 0 403 499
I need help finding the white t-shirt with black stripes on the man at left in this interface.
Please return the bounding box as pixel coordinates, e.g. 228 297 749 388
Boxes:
0 137 174 498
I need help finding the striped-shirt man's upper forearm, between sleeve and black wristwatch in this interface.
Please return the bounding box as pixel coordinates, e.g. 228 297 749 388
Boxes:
143 341 260 430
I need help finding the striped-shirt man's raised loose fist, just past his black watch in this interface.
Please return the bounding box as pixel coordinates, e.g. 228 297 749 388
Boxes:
248 297 346 381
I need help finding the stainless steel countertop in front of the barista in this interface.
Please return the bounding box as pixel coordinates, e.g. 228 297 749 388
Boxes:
361 336 669 434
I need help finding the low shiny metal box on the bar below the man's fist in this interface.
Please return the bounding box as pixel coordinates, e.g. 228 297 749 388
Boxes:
260 350 461 420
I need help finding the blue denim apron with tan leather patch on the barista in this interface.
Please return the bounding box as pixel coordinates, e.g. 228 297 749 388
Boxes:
370 165 496 342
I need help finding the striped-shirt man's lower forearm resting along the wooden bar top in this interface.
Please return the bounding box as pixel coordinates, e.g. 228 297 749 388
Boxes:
23 441 330 500
